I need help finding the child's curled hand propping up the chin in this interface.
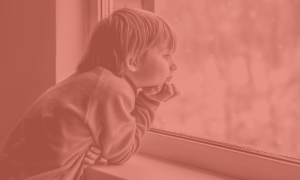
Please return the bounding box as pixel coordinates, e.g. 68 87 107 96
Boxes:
142 81 180 102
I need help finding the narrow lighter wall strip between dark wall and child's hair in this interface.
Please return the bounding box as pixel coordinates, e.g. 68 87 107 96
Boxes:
56 0 85 82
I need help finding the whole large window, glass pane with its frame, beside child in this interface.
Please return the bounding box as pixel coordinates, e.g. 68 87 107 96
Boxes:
91 0 300 179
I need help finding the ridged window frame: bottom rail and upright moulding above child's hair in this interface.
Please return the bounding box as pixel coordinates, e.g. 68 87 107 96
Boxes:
92 0 300 180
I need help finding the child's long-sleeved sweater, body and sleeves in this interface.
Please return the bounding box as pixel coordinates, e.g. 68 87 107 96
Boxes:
0 67 159 180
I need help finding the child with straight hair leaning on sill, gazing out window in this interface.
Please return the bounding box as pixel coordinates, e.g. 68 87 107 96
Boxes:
0 8 179 180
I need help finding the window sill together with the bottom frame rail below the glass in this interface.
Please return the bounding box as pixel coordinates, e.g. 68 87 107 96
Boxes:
85 130 300 180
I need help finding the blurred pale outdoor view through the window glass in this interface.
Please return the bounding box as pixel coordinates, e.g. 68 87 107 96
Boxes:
115 0 300 158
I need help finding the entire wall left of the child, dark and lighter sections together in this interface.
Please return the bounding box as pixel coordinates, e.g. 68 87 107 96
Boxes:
0 0 88 141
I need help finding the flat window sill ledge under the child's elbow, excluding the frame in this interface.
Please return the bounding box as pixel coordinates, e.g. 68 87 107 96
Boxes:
85 153 237 180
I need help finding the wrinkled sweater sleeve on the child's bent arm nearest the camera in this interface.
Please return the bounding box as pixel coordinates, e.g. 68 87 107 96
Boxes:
87 89 159 164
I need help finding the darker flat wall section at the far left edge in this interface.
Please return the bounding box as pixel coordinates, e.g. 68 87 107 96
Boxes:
0 0 56 141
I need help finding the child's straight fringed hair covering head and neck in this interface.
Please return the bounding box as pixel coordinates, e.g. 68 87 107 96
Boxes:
77 8 177 77
